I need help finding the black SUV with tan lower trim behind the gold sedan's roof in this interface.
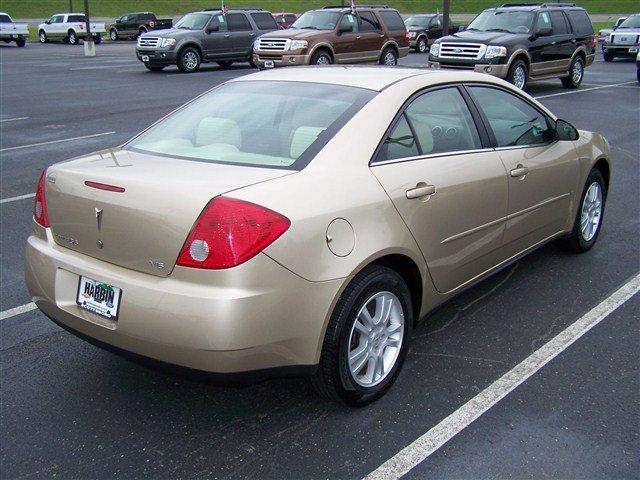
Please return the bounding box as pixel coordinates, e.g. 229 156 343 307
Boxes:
429 3 597 89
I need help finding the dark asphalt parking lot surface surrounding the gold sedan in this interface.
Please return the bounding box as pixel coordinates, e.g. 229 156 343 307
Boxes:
0 42 640 479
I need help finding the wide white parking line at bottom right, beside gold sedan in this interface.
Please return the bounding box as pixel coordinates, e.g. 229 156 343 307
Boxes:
365 274 640 480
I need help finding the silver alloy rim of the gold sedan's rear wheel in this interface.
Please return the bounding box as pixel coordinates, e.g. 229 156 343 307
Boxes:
348 292 404 387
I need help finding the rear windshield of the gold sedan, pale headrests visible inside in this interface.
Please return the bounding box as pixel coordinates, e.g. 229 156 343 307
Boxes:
124 81 376 170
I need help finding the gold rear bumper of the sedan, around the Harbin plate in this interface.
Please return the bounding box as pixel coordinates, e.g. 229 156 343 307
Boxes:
25 224 342 374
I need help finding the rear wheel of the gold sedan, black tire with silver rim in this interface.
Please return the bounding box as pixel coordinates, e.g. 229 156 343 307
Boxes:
312 265 413 406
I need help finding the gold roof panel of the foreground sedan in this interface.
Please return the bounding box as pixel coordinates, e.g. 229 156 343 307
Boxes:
231 65 493 91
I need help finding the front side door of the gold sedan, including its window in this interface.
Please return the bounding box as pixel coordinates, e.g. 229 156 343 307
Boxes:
469 86 582 256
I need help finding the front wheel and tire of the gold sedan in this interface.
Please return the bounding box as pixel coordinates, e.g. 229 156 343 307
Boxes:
564 168 607 253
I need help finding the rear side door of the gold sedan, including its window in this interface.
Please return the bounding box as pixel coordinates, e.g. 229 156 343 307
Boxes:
371 86 508 292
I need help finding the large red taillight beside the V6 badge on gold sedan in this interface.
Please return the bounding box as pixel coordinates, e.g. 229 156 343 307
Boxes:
177 197 291 270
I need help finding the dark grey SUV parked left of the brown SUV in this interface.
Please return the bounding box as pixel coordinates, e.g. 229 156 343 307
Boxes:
136 9 278 73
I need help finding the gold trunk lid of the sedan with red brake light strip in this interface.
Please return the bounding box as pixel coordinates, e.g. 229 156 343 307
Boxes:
46 150 293 276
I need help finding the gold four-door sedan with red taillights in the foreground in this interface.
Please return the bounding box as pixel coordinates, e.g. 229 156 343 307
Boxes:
26 67 611 405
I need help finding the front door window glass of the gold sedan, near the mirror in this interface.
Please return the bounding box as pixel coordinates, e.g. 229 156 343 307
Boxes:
471 87 555 147
